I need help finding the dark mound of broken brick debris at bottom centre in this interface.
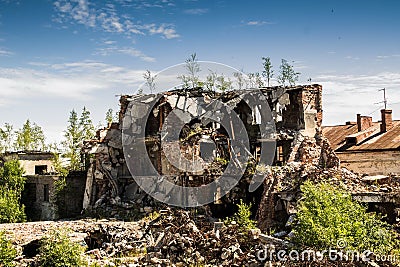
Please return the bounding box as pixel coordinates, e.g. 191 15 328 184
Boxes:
139 210 260 266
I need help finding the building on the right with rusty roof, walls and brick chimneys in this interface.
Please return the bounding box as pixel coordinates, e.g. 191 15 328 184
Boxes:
322 109 400 175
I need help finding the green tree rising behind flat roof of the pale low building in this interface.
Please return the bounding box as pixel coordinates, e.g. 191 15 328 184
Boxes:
15 119 46 151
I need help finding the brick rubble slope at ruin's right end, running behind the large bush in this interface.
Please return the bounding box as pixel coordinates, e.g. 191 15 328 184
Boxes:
257 137 400 230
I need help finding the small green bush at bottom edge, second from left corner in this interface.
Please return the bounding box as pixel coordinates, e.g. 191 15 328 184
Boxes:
39 230 84 267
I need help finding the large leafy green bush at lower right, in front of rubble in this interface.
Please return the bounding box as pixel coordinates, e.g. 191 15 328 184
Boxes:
293 181 400 255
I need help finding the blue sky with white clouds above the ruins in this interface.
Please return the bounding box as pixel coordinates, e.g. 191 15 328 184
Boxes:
0 0 400 141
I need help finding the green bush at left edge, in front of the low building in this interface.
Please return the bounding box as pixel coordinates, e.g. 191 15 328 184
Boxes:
0 160 26 223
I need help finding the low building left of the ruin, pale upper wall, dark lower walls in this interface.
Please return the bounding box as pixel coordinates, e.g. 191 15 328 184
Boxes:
0 151 86 221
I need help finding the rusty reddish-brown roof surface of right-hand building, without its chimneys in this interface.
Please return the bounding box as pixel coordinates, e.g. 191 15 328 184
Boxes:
322 121 400 151
